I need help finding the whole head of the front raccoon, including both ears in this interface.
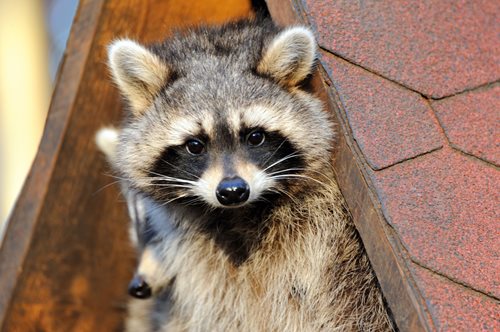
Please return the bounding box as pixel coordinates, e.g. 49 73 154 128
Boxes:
109 22 333 208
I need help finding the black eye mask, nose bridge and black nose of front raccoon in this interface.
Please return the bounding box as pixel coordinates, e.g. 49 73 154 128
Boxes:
151 125 304 208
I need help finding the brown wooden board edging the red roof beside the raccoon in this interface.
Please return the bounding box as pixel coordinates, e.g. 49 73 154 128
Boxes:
326 78 432 331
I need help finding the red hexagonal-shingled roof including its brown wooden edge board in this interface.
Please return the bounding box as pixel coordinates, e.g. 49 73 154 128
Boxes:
269 0 500 331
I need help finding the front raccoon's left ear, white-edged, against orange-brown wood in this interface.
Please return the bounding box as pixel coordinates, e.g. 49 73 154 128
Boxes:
108 39 170 115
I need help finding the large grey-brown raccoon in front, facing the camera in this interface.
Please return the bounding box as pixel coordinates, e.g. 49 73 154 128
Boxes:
98 19 394 331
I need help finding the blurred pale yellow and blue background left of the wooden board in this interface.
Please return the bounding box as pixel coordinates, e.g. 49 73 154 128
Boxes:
0 0 78 241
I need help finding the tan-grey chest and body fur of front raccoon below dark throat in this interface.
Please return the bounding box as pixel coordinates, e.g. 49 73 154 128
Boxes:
129 180 390 331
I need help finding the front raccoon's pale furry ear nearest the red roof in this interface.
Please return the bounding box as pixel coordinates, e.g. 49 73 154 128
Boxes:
257 27 316 86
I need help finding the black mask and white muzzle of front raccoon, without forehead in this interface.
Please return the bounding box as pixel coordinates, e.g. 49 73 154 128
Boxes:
146 115 304 207
